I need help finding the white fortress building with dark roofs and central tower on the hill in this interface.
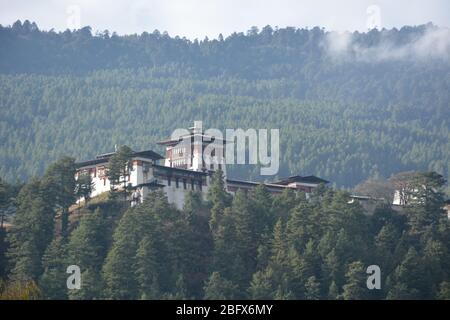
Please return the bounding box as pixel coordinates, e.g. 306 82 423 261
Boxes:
75 122 328 209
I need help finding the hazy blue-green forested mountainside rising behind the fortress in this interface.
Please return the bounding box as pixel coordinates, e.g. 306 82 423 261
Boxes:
0 21 450 187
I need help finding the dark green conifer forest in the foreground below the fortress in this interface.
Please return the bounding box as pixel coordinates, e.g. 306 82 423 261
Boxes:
0 156 450 300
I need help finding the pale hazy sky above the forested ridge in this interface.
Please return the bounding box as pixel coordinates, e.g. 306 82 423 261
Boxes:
0 0 450 39
